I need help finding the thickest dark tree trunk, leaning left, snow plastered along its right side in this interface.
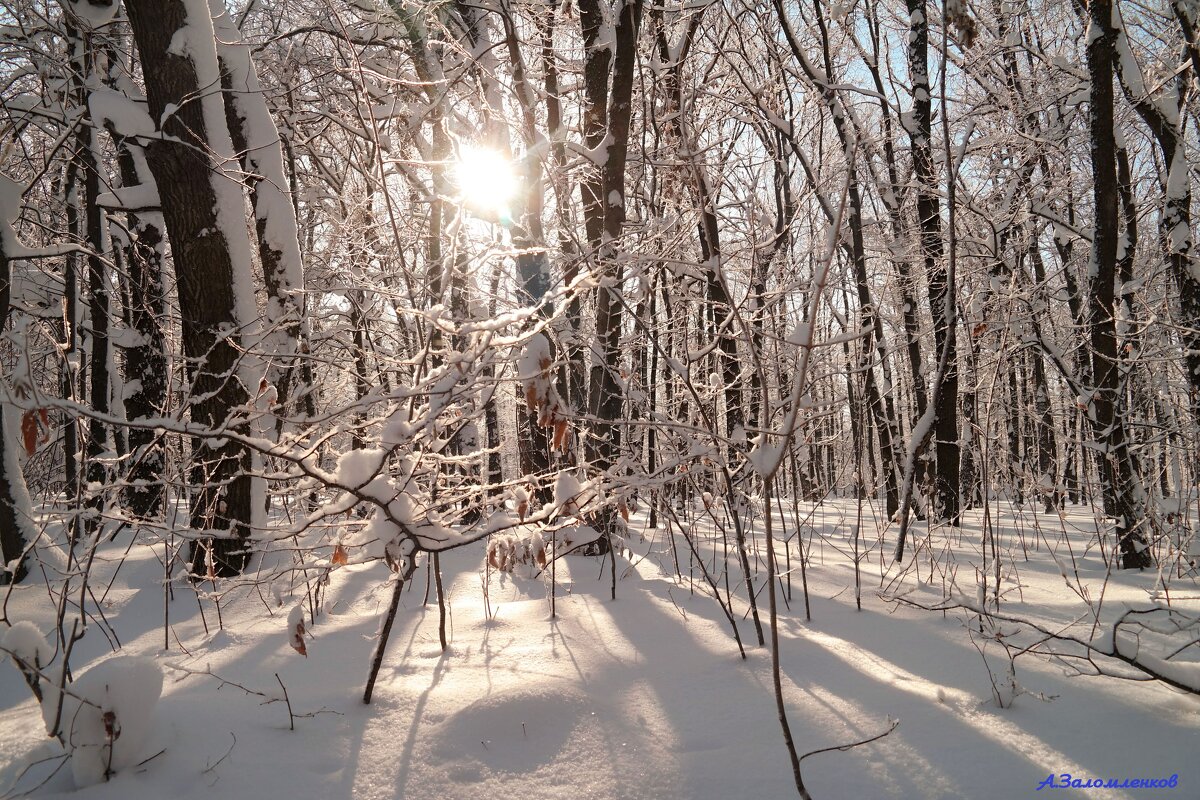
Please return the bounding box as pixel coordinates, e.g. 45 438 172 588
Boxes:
125 0 251 577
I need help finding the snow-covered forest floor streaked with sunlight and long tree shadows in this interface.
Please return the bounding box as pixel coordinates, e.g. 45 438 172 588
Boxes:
0 500 1200 800
